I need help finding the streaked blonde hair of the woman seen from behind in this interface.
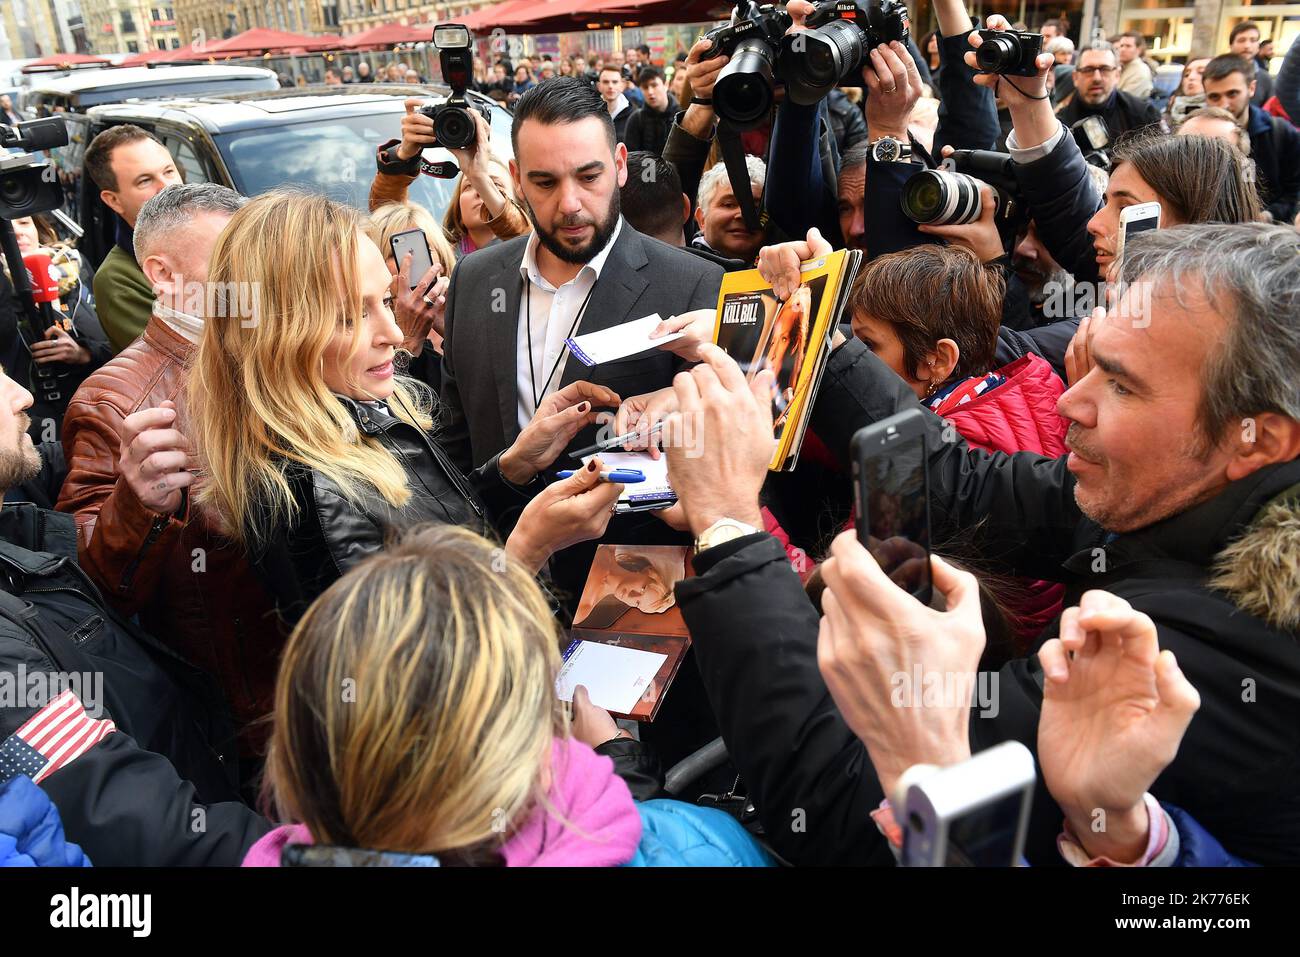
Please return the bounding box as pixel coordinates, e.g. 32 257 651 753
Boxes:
265 525 568 863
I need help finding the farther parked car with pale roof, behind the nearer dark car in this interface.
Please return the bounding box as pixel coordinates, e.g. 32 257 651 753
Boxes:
20 66 280 117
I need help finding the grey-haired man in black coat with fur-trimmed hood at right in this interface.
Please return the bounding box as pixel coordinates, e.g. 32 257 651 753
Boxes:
668 224 1300 863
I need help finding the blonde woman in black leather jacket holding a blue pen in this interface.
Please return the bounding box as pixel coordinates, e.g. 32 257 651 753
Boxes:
187 191 621 623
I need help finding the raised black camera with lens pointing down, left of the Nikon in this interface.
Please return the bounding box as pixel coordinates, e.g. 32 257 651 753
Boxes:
701 0 794 130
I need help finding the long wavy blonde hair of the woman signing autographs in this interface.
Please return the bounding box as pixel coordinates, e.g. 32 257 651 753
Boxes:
187 190 432 544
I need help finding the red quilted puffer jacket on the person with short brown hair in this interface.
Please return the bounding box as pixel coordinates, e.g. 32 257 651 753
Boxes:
936 354 1069 642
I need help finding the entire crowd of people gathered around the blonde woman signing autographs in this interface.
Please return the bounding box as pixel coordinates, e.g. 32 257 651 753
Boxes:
0 0 1300 866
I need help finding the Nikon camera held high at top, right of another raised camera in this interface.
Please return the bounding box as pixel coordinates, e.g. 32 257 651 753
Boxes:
779 0 909 107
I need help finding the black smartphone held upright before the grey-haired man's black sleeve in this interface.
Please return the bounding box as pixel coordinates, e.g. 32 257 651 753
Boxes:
850 408 932 605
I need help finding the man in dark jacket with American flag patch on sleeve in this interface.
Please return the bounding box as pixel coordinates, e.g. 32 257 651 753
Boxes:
0 361 270 866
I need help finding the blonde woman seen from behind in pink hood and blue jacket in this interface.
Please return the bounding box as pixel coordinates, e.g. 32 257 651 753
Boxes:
244 525 770 867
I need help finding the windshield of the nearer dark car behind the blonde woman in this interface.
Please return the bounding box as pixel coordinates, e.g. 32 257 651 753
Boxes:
213 101 512 221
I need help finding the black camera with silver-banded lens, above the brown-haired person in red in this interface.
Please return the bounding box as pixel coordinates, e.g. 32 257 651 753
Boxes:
901 150 1028 248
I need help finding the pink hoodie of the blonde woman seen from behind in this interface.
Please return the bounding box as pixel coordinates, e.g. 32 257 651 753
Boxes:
243 737 641 867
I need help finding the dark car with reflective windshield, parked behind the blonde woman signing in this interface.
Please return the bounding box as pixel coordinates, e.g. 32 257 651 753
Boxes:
56 83 514 265
